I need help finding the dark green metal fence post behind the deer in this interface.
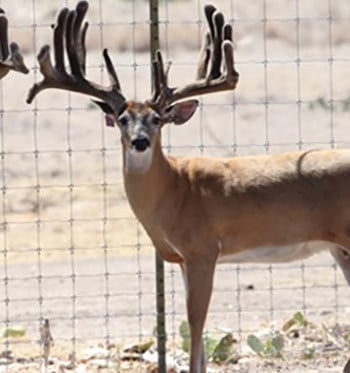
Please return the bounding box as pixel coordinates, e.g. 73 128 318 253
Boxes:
150 0 166 373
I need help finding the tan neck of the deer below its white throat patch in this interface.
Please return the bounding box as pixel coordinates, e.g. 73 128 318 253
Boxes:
123 139 176 223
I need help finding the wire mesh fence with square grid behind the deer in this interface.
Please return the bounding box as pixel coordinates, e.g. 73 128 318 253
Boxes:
0 0 350 372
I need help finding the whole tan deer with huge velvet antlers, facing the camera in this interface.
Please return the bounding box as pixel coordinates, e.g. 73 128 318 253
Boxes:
28 2 350 373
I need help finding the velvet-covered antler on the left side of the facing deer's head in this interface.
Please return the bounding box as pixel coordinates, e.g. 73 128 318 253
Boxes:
27 1 125 113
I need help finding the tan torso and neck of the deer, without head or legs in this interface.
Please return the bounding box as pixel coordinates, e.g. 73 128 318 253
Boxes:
124 144 350 263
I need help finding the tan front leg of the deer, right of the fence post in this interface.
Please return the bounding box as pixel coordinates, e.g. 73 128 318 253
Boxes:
181 258 216 373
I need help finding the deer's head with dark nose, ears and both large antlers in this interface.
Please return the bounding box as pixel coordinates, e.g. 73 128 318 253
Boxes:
27 1 238 172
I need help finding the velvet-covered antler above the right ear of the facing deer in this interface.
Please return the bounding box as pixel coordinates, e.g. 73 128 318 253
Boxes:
149 5 239 113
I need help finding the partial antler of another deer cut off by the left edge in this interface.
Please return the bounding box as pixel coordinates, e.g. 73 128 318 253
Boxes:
0 9 29 79
